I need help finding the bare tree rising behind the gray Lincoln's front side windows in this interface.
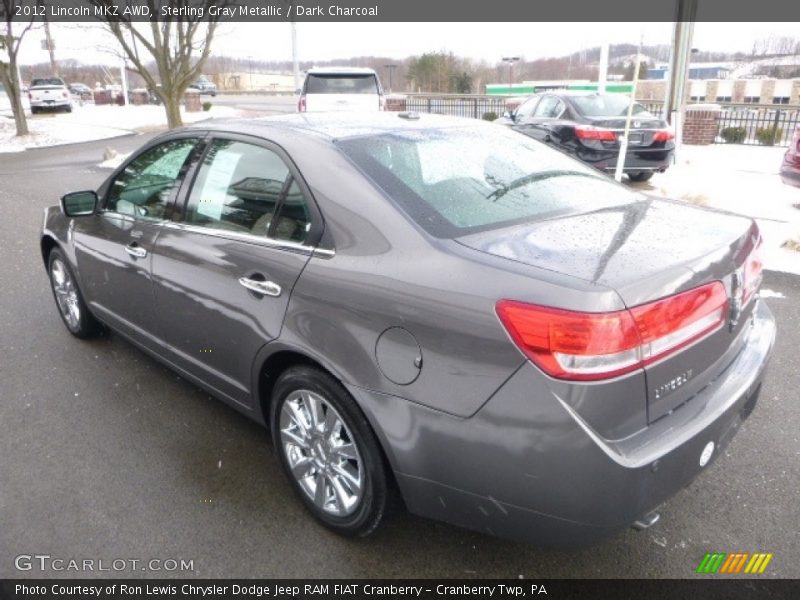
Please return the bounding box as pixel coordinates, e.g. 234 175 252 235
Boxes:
90 0 227 128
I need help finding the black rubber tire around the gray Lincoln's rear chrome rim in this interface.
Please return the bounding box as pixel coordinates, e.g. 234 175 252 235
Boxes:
270 366 388 537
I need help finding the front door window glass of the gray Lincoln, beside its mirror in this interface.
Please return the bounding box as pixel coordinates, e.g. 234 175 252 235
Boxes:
106 138 197 219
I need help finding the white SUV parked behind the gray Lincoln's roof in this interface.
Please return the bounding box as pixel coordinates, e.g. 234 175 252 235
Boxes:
297 67 386 112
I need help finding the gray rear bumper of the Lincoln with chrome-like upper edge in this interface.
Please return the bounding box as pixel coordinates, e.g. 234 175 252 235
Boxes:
353 302 775 546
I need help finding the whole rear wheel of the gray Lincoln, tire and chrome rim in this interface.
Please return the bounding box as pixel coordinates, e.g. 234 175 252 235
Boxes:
270 366 387 536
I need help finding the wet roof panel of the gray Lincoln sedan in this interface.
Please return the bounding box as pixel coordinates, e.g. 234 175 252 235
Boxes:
187 111 488 140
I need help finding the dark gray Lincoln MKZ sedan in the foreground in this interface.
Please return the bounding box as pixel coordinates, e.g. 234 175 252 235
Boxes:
41 113 775 545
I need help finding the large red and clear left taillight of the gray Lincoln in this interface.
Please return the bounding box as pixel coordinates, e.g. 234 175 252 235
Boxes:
497 281 728 381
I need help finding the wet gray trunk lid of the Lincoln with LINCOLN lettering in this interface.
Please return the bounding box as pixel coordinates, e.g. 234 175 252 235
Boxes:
457 199 759 422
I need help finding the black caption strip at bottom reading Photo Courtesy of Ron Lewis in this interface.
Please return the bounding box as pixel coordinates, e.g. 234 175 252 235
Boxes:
0 578 800 600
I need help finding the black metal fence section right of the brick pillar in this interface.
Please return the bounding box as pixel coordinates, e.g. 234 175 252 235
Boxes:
715 104 800 146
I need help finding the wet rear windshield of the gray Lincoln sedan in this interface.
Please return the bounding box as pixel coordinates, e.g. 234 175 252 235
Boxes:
337 125 641 238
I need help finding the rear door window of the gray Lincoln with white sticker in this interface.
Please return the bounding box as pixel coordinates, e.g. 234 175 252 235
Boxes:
186 140 311 243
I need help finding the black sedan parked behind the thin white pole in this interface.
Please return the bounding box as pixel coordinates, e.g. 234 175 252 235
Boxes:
496 90 675 181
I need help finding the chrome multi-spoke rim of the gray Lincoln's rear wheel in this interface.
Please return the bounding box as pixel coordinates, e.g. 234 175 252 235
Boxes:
280 390 364 517
